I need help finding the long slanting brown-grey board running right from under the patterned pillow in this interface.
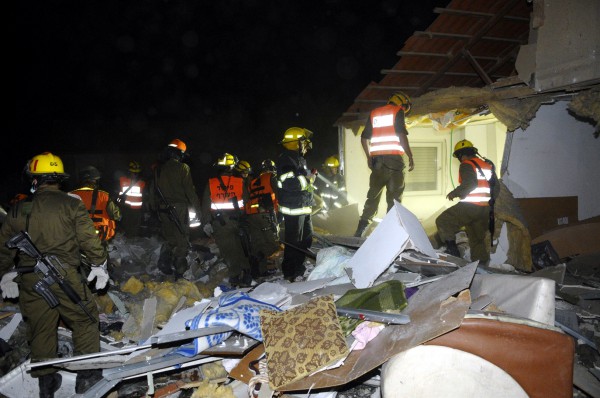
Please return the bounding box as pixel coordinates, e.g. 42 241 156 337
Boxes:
281 262 477 391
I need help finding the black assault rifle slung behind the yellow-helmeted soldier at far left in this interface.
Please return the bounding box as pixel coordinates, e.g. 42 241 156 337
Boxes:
6 231 97 322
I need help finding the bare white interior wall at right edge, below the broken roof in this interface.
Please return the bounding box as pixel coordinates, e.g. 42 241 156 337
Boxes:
503 101 600 220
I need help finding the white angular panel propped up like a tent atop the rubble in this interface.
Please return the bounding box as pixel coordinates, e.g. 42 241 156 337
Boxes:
346 202 438 289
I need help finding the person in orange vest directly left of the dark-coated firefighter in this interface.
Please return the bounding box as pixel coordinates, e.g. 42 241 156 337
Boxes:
246 159 280 278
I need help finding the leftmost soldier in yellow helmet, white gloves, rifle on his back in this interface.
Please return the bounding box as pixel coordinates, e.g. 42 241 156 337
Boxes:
0 152 109 397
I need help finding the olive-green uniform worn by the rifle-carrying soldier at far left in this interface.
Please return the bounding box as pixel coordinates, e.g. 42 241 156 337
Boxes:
0 185 106 377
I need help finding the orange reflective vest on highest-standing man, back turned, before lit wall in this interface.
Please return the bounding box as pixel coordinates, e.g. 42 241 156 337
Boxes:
369 104 404 156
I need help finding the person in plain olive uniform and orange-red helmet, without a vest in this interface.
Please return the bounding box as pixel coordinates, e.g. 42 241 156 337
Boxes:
148 138 201 278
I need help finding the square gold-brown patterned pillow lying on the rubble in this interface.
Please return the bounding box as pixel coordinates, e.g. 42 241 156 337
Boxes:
260 295 349 390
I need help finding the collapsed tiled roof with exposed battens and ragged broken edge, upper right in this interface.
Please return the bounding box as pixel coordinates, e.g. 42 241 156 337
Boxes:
335 0 600 131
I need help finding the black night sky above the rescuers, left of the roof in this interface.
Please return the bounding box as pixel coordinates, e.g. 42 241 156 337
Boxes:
11 0 448 202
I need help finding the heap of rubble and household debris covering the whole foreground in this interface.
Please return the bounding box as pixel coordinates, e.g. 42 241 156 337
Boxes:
0 203 600 398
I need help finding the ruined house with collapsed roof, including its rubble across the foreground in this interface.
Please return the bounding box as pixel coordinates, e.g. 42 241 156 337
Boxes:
0 0 600 398
